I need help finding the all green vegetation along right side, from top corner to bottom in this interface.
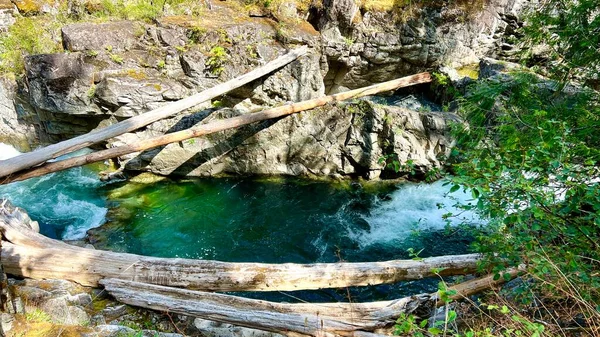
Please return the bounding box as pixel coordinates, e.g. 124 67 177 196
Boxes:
418 0 600 336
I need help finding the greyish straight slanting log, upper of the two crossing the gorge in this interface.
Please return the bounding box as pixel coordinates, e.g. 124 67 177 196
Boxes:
0 46 307 178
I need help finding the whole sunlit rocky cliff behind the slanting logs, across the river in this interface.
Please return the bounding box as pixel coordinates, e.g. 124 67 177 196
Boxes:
0 0 521 177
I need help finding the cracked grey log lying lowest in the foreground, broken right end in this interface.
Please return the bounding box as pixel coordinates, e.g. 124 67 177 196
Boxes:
100 270 518 336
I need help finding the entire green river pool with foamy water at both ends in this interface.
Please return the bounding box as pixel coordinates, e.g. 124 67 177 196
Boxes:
0 144 476 300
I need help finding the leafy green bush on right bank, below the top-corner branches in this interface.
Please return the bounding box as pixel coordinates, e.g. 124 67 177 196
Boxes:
452 69 600 308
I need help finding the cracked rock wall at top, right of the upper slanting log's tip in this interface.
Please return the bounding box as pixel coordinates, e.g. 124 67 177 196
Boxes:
309 0 524 92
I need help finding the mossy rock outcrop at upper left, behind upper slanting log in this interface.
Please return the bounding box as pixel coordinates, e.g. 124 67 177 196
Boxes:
20 11 324 142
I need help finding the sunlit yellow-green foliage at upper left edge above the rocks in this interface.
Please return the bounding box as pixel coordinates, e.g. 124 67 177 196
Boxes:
0 17 62 75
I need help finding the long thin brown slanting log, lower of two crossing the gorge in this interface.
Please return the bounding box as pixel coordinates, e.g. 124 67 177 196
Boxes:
0 73 431 183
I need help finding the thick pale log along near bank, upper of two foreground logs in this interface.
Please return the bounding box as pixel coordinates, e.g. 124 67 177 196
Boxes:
0 218 479 292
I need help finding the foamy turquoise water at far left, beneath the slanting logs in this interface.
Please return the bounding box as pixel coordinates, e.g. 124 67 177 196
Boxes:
0 143 108 240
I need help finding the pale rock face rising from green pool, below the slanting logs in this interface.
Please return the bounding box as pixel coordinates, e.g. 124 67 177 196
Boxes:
111 101 456 179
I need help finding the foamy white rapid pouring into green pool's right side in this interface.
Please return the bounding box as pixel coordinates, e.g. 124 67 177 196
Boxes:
348 181 482 248
